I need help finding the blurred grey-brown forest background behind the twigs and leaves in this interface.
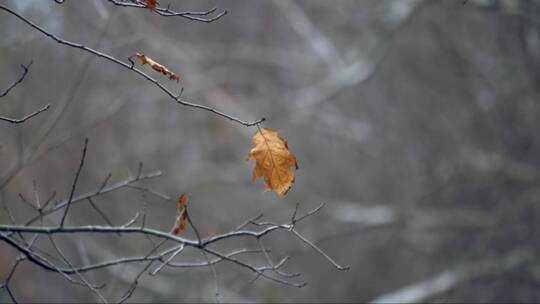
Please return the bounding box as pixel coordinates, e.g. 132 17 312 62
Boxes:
0 0 540 302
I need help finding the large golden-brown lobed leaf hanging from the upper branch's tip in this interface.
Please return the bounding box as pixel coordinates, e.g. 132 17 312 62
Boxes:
248 128 298 196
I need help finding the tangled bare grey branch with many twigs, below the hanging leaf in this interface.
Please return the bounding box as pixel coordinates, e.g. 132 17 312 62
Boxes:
0 139 348 303
